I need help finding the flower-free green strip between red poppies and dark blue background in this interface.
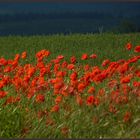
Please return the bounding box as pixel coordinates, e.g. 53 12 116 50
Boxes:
0 33 140 65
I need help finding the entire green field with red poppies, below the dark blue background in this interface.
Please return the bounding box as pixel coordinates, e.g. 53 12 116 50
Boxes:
0 33 140 138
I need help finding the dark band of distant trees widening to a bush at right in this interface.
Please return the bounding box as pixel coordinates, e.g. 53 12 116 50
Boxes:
0 11 140 33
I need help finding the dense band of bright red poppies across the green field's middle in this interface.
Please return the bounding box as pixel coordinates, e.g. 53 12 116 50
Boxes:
0 43 140 124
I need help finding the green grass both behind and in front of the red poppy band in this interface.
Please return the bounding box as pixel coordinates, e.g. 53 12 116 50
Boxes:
0 33 140 138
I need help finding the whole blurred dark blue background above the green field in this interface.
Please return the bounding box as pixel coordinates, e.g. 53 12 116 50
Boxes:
0 2 140 35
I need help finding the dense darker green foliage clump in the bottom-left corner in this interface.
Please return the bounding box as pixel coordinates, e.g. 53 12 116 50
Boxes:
0 106 24 138
